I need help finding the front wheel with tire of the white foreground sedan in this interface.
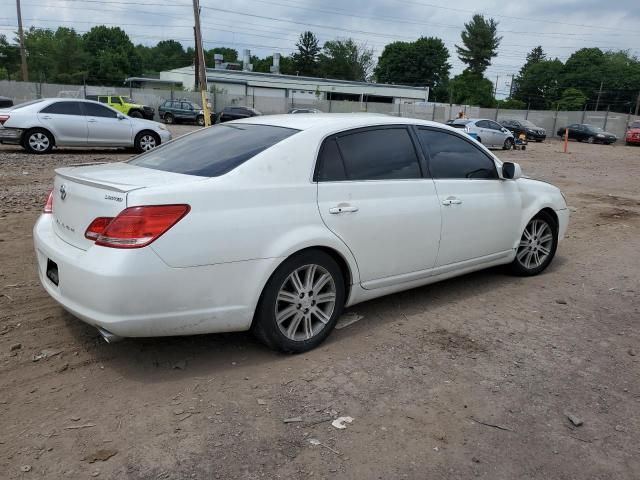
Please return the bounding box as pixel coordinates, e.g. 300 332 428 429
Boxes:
511 212 558 276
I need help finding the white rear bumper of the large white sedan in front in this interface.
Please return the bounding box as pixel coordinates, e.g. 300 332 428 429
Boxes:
33 215 276 337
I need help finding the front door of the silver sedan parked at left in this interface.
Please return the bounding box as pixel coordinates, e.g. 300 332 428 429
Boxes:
82 102 133 147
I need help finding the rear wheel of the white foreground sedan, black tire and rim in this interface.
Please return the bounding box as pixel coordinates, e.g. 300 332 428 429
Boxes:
252 250 345 353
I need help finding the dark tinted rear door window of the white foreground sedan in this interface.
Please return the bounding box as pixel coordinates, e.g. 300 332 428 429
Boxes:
338 128 422 180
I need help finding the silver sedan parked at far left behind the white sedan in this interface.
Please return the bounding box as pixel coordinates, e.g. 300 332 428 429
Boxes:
0 98 171 153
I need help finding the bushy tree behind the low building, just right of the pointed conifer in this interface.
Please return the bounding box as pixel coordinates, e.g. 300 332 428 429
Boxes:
318 38 373 81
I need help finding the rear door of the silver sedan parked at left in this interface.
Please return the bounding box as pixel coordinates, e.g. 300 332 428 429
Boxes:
38 101 88 146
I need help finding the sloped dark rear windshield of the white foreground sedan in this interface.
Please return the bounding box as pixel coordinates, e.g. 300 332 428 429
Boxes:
129 124 299 177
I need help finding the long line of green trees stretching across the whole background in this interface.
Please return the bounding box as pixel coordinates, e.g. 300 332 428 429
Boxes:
0 14 640 111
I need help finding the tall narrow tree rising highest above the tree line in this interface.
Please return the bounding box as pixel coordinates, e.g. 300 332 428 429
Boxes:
456 14 502 75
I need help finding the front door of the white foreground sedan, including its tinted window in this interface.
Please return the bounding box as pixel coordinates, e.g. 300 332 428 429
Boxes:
418 127 522 267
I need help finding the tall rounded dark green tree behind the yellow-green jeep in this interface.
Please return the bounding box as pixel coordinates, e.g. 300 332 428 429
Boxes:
84 25 142 85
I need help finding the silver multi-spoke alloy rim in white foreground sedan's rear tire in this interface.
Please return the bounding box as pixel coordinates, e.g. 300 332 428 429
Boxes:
275 264 336 341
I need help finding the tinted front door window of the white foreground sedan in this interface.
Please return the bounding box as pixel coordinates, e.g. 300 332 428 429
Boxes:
418 129 498 179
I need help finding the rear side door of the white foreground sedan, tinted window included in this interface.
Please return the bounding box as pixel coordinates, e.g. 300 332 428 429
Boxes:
315 126 440 289
